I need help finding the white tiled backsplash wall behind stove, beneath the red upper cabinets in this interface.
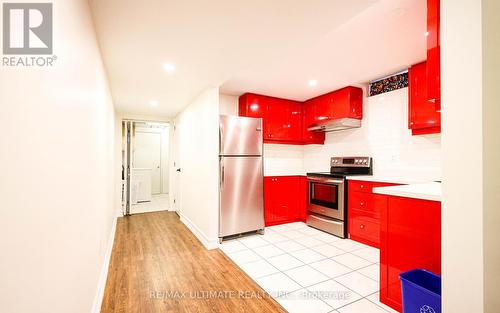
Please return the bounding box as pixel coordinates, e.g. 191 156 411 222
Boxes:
304 88 441 179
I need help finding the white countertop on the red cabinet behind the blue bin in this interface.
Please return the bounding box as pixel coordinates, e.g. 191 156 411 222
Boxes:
373 182 441 201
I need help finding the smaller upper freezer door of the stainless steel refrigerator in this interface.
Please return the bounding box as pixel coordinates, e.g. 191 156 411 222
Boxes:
219 115 262 156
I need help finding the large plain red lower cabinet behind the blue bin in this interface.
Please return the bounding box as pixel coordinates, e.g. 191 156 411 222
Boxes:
380 196 441 312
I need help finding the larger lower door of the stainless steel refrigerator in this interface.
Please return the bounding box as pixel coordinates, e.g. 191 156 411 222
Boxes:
219 157 264 237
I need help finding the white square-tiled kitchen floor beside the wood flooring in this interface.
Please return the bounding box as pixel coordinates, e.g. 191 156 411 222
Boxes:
221 222 396 313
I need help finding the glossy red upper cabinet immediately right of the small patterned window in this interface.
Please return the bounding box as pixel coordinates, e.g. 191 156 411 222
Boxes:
408 62 441 135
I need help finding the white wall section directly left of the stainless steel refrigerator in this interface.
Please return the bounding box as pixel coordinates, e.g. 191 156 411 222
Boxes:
171 88 219 249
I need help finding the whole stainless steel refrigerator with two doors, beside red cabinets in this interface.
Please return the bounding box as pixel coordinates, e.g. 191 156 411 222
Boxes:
219 115 264 239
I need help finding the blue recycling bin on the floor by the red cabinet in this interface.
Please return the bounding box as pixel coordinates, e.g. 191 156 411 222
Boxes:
399 269 441 313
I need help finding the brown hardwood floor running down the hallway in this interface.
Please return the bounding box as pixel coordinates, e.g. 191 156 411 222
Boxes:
101 211 286 313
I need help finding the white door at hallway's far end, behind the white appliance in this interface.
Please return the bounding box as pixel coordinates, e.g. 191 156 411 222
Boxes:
134 131 161 194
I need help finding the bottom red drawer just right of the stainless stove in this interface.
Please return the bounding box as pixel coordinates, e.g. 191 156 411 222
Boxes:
349 210 380 248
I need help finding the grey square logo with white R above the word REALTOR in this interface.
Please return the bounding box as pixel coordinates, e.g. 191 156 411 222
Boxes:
2 3 52 55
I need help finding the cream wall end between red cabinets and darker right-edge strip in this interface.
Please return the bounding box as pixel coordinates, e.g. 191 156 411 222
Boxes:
441 0 484 313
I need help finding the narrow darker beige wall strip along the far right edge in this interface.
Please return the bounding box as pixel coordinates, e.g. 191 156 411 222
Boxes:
482 0 500 313
